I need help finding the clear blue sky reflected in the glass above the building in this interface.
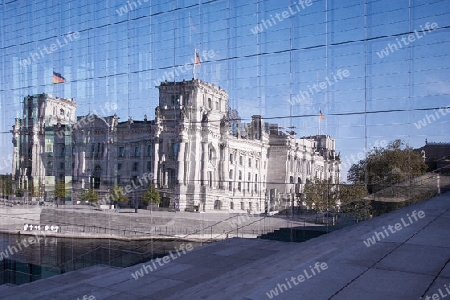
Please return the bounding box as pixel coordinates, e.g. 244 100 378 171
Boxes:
0 0 450 176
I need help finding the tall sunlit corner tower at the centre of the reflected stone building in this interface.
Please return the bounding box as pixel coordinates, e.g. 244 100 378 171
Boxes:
155 79 228 211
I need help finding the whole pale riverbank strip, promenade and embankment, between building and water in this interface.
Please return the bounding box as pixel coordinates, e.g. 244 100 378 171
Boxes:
0 200 319 241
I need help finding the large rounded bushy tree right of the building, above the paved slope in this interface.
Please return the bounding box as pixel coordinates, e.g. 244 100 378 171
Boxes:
347 139 427 193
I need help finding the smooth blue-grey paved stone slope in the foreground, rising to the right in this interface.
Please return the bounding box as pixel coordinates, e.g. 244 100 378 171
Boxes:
0 193 450 300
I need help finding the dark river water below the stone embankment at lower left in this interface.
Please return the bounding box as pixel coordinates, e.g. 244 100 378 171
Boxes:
0 233 206 284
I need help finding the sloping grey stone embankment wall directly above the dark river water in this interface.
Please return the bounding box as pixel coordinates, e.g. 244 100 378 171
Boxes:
40 209 286 240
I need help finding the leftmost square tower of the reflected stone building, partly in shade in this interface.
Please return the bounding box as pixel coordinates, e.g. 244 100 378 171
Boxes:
12 94 76 197
